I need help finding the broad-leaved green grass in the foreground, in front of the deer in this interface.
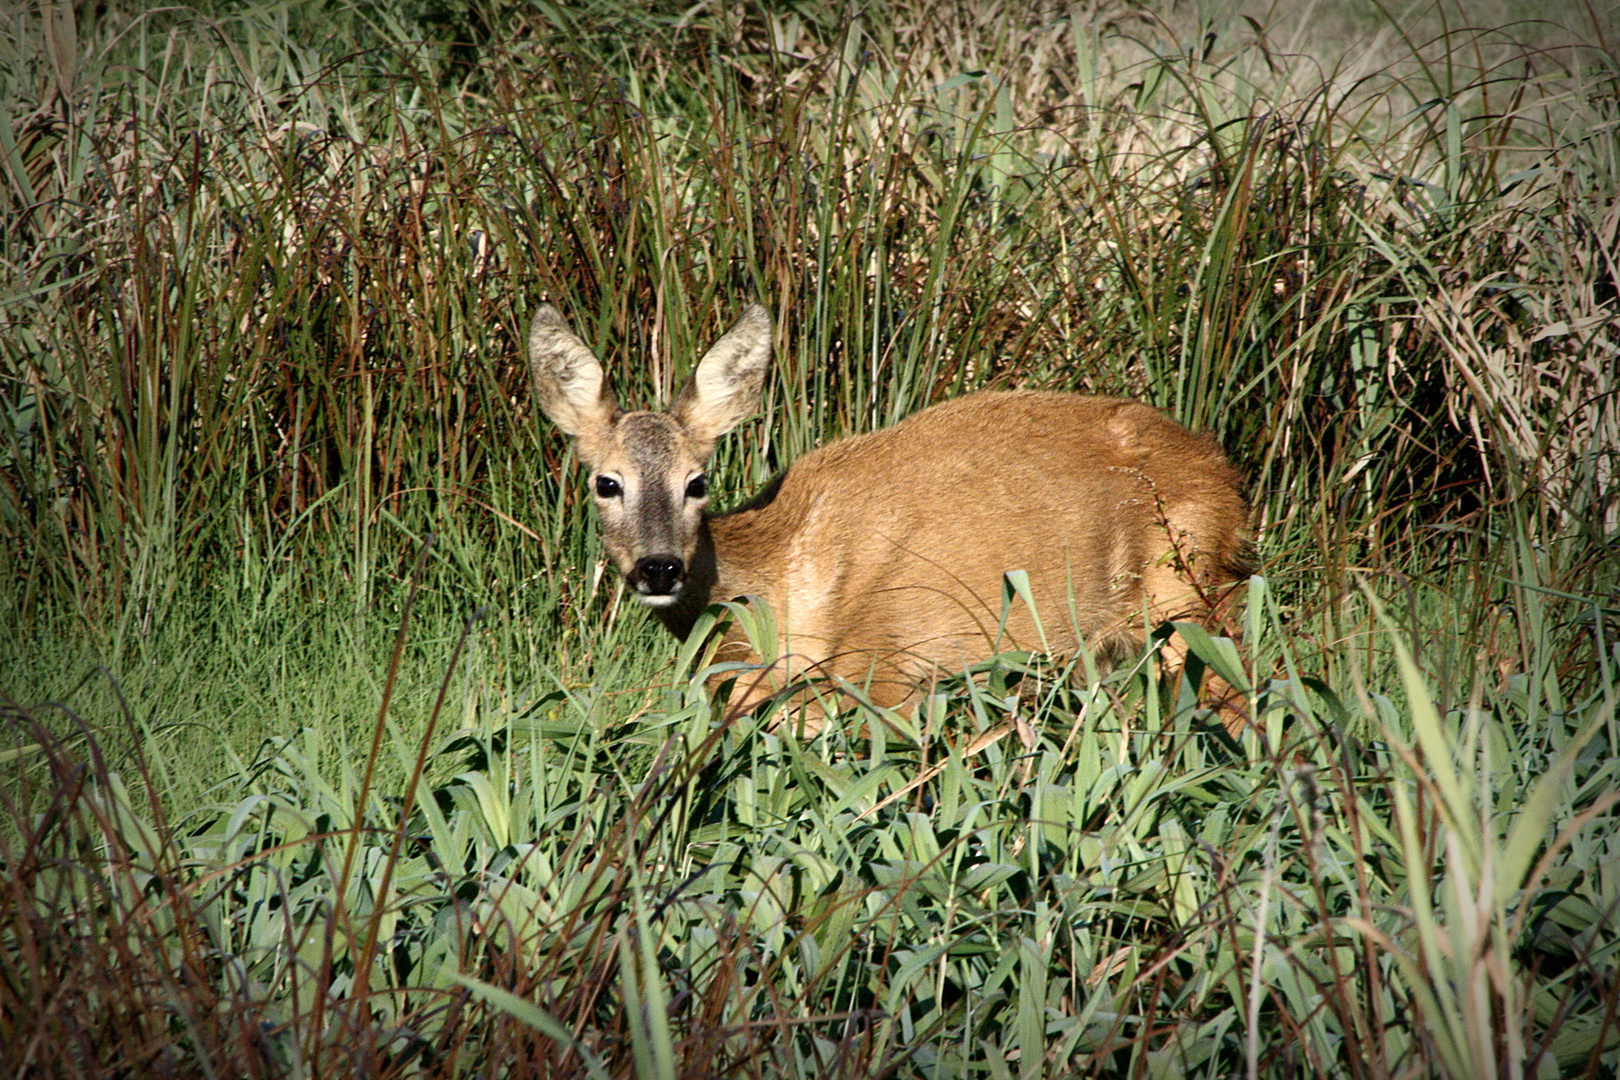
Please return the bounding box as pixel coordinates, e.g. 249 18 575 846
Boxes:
0 580 1617 1077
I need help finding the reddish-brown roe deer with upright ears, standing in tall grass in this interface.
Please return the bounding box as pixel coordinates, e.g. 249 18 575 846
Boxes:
528 304 1247 730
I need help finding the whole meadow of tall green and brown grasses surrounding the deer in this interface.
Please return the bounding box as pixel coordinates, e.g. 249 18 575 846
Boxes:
0 0 1620 1080
